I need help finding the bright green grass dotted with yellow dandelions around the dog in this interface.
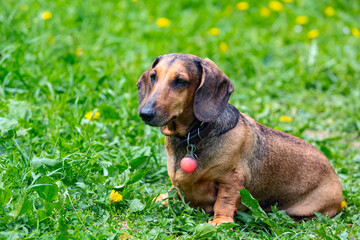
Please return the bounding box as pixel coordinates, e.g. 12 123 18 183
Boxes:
0 0 360 239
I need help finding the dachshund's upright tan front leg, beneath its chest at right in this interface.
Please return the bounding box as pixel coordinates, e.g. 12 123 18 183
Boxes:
209 174 244 226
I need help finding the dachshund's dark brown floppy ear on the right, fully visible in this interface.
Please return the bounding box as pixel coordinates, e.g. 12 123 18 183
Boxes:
194 58 234 122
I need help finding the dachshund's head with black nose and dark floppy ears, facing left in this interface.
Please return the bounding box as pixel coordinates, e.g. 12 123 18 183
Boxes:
136 53 234 135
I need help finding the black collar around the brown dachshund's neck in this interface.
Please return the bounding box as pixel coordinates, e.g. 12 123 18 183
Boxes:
177 122 212 147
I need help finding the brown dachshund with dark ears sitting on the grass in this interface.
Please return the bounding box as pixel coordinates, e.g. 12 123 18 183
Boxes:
137 53 342 225
